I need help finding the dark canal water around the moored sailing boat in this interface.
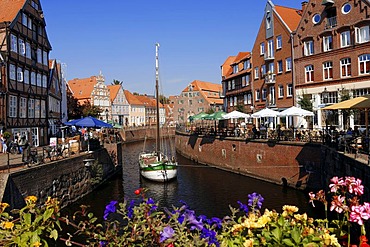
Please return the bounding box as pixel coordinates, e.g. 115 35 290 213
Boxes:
65 141 315 218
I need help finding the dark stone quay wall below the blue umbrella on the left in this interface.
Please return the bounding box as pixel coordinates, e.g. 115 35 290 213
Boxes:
0 144 122 208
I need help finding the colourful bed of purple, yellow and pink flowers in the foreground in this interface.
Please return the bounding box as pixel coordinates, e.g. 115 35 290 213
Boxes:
0 177 370 247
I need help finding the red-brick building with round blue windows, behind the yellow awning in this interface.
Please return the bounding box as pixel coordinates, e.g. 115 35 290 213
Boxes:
294 0 370 128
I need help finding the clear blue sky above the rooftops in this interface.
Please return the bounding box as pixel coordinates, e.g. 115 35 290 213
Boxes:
41 0 302 96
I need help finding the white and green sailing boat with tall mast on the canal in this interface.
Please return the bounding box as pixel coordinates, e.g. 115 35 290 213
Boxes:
139 43 178 182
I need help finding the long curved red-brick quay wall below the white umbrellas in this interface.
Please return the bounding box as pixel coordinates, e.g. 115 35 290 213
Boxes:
175 132 370 194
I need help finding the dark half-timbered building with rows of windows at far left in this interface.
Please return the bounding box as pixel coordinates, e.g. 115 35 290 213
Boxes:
0 0 51 146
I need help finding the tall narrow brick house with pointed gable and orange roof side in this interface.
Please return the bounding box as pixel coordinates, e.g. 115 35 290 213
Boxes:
251 0 301 111
